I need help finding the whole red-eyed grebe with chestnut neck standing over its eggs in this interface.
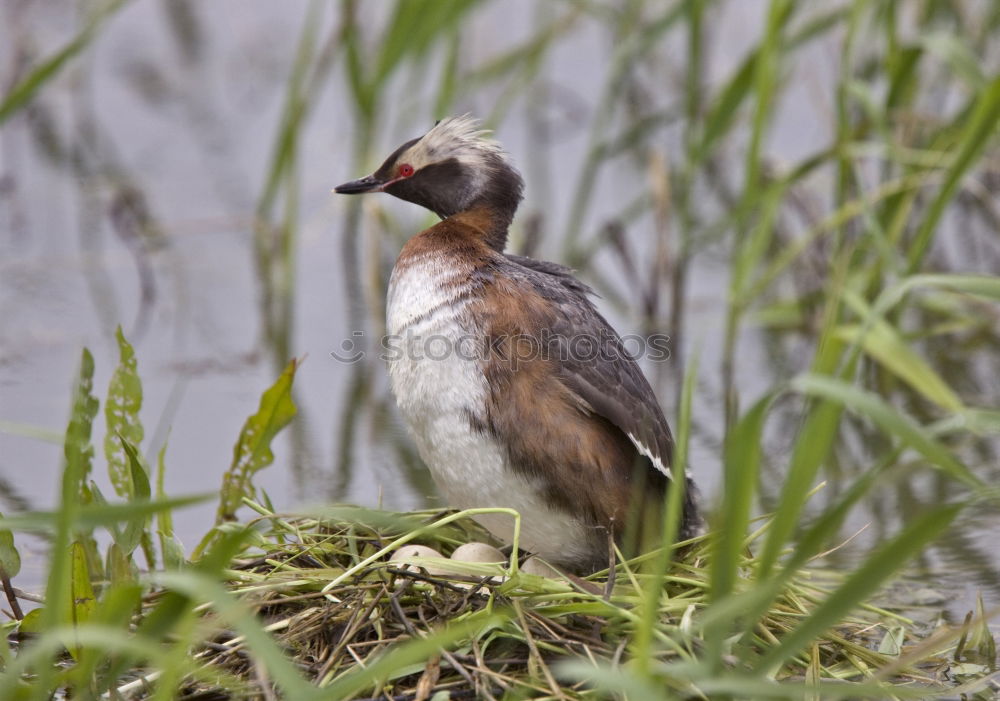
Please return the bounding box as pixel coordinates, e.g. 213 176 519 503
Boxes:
337 118 701 570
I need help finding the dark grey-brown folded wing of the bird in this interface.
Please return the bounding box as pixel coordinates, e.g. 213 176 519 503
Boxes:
505 255 673 478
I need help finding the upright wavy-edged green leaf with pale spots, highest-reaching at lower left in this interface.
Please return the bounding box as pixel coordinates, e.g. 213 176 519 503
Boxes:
104 326 143 498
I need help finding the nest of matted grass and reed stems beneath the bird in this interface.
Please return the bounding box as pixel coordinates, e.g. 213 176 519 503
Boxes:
160 510 988 701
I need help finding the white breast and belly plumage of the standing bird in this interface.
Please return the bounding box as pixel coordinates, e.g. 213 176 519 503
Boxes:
386 257 592 563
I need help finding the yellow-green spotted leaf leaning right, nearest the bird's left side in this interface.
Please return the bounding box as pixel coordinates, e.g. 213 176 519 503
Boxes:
216 359 298 523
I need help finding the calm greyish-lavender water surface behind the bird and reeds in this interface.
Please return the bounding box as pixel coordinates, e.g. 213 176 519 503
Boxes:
0 0 1000 616
